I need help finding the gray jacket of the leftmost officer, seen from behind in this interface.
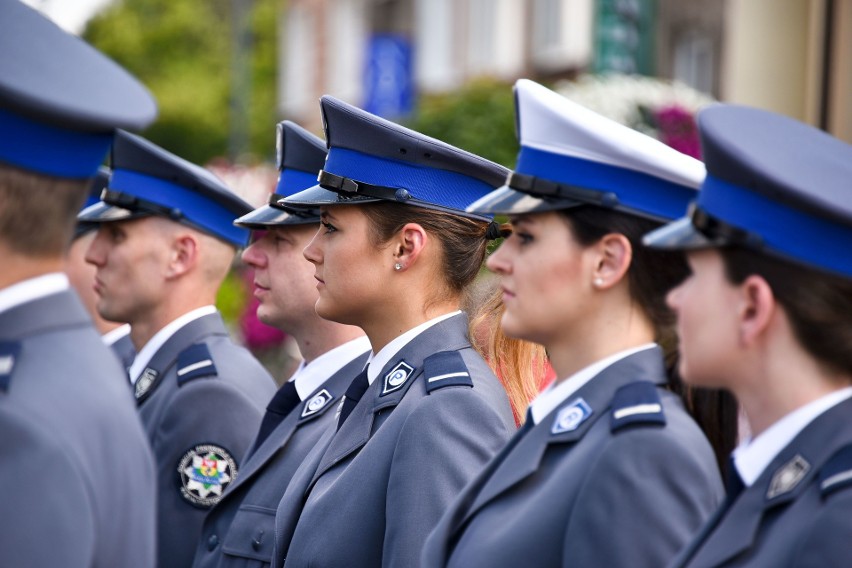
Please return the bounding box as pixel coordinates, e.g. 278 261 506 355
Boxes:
0 291 156 568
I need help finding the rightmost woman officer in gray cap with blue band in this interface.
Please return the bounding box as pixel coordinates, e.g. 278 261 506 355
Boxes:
647 105 852 568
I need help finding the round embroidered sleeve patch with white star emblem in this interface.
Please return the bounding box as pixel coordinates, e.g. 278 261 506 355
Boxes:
177 444 237 509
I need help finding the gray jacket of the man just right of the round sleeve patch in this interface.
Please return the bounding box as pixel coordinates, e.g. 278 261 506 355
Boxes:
194 353 369 568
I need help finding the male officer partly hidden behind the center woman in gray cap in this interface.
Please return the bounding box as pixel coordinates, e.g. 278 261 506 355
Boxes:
194 121 370 568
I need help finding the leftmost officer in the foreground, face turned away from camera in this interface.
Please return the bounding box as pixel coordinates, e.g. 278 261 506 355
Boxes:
0 0 156 567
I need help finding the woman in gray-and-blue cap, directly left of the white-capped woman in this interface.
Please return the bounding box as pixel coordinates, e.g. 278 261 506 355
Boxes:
268 96 515 568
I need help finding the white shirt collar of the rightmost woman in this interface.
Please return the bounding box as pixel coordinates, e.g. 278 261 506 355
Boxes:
733 387 852 487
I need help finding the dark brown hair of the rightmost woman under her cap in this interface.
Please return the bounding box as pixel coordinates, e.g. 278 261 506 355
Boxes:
720 247 852 376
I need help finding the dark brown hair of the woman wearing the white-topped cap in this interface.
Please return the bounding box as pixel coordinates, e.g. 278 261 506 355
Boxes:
560 207 737 470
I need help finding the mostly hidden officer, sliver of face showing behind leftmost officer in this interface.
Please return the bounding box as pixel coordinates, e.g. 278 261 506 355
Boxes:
65 166 136 369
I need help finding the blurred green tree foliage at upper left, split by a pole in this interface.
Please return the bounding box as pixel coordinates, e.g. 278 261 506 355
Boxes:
84 0 281 164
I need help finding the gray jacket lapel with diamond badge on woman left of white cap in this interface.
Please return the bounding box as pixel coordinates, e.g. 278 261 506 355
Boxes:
310 314 470 487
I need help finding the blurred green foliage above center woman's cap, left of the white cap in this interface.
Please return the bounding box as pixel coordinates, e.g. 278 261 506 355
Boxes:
407 79 518 168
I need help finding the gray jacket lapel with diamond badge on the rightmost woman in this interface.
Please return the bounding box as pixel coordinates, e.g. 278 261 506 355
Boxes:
680 399 852 568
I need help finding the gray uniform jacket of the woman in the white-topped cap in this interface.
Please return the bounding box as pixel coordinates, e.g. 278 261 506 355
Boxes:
422 348 723 568
